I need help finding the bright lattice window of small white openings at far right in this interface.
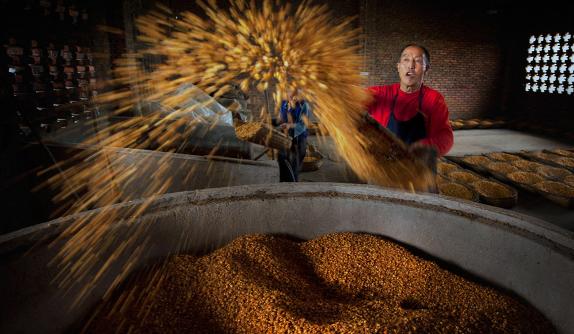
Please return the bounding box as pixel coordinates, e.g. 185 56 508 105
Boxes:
524 32 574 95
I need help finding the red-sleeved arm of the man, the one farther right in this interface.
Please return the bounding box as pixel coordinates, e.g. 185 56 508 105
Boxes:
420 95 453 156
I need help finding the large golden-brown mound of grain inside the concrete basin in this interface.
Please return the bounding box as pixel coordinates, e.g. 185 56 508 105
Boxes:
87 233 554 334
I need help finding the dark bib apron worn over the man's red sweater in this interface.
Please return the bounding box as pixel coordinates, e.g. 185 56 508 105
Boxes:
387 86 427 145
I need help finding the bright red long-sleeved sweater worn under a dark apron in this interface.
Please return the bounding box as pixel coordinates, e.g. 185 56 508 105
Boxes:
369 83 453 155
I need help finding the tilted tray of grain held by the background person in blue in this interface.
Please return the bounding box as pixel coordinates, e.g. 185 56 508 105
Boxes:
235 122 292 150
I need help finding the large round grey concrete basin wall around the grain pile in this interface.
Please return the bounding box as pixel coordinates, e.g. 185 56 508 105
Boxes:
0 183 574 333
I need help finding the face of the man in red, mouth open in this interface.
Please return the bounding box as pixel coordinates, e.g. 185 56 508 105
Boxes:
397 46 426 90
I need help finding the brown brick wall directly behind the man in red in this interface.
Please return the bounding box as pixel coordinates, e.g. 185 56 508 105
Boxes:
361 0 503 119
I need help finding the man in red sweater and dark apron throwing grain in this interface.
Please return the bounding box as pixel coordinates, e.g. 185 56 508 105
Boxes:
369 44 453 164
